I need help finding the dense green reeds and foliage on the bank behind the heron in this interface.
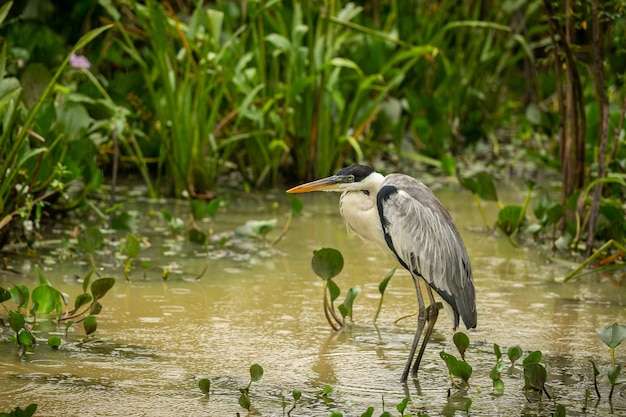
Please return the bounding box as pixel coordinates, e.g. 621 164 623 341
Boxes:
0 0 626 272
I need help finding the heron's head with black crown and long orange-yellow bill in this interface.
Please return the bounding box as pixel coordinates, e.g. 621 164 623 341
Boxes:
287 165 384 193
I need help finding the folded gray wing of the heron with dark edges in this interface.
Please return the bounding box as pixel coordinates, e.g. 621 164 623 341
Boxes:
376 174 476 329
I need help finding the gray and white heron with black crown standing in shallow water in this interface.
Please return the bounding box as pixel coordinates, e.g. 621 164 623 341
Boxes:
287 165 477 382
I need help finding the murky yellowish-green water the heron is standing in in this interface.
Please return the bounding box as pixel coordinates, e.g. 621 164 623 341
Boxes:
0 190 626 416
